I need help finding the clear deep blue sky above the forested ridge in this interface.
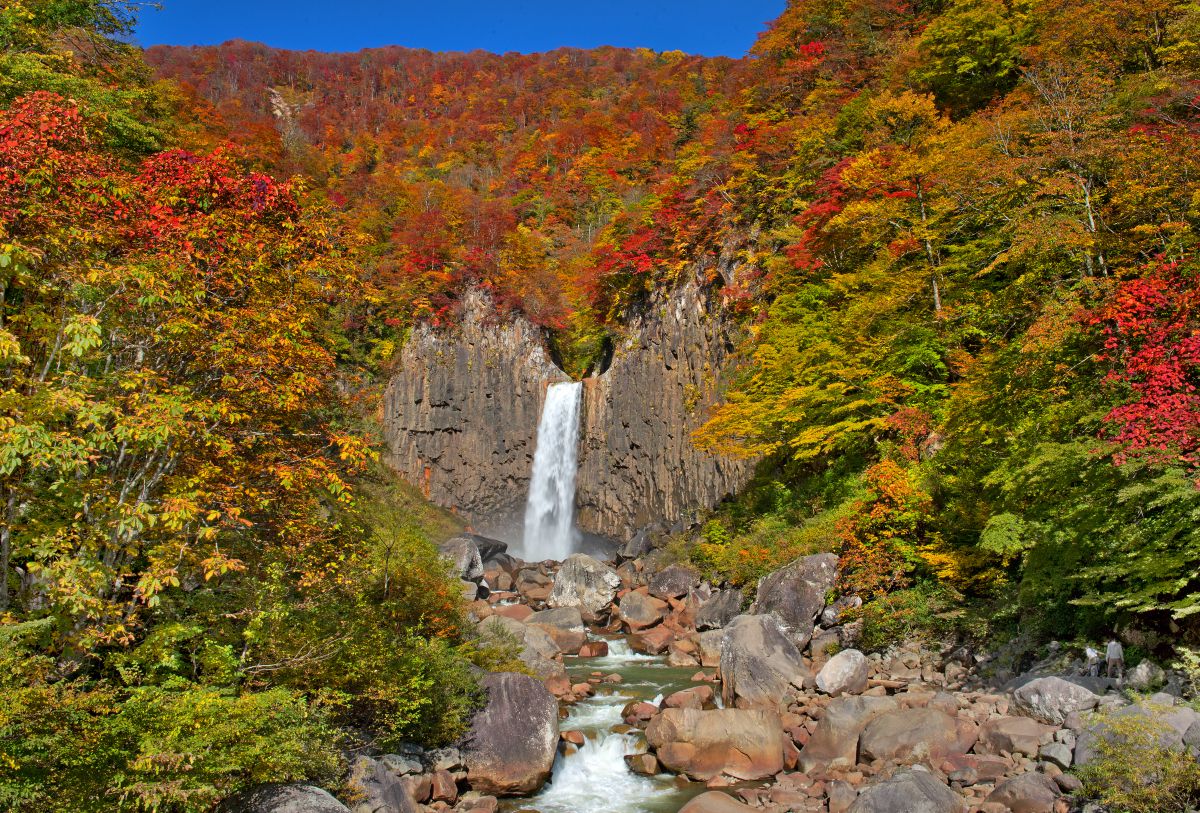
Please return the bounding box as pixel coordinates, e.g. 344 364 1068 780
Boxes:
136 0 785 56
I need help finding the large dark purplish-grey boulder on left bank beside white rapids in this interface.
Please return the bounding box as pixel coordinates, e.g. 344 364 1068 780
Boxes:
462 672 558 796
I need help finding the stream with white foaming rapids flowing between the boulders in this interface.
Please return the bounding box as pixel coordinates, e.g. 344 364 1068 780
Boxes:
505 638 704 813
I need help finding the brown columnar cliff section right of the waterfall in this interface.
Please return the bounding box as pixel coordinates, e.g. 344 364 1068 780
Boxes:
576 283 752 538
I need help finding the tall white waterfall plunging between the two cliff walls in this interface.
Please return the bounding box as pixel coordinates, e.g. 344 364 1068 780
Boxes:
522 381 583 561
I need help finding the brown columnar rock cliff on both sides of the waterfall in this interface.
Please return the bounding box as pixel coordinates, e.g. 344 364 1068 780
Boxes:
384 283 751 540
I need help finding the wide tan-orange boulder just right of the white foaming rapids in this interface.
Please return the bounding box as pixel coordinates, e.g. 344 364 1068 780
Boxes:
646 709 784 782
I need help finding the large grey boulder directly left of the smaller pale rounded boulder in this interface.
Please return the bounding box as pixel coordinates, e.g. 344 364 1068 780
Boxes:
721 615 812 709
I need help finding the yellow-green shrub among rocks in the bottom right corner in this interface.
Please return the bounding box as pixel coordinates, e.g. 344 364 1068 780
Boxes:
1078 715 1200 813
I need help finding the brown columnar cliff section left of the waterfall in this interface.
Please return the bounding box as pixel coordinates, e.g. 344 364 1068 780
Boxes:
384 291 569 535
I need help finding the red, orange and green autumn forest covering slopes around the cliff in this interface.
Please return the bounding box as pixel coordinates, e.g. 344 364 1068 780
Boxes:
7 0 1200 811
